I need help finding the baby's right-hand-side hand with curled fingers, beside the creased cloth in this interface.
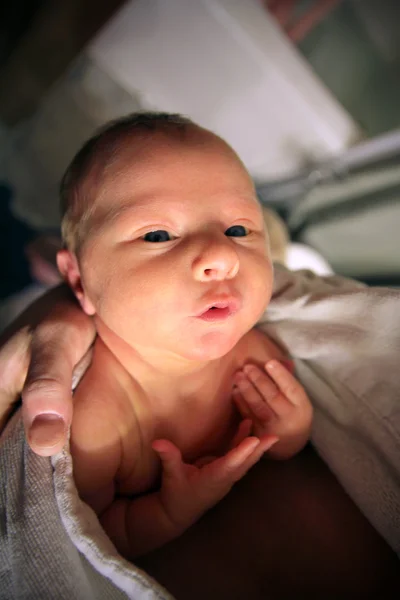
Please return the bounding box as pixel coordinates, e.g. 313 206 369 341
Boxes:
233 360 313 459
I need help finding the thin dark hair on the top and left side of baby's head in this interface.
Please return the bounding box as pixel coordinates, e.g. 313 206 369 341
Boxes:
60 112 194 252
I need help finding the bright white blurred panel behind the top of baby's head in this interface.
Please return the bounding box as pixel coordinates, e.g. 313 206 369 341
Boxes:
88 0 360 179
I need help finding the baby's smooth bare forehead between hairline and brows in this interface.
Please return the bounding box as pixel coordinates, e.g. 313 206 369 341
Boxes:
84 125 254 220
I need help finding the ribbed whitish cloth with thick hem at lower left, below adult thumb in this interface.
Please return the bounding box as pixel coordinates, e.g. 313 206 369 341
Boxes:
0 413 171 600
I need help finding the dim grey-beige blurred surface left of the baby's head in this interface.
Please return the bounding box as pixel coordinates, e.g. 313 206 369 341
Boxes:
0 54 141 228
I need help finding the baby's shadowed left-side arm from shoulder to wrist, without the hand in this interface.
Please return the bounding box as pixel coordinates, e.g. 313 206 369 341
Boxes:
71 380 188 559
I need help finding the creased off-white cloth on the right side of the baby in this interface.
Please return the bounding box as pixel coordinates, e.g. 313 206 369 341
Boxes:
260 267 400 557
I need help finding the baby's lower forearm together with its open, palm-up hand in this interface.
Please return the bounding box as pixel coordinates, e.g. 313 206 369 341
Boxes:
101 436 276 560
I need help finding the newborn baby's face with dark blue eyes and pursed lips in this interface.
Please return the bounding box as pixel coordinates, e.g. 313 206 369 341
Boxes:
76 130 272 360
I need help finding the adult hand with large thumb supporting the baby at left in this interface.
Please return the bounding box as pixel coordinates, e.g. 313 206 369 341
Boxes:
0 286 95 456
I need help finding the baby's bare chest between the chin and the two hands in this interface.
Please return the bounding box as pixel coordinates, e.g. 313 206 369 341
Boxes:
116 329 284 495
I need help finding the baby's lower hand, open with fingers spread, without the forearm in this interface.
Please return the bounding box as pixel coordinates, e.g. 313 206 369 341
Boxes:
152 432 277 534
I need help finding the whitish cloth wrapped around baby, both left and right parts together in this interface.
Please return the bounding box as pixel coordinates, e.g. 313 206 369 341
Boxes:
0 267 400 600
